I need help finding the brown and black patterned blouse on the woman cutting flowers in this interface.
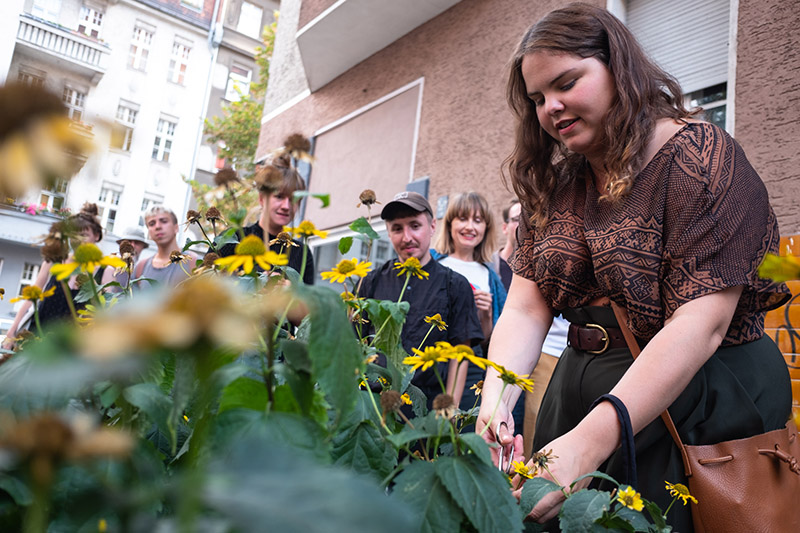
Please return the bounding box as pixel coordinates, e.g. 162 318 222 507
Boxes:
511 123 789 346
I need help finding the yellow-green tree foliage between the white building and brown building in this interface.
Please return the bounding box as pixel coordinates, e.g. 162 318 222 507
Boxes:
204 11 278 177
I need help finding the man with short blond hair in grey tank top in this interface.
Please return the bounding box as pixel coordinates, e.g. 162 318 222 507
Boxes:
133 205 196 287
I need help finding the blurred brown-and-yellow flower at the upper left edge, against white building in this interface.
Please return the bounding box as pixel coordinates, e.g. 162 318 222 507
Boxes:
0 83 92 198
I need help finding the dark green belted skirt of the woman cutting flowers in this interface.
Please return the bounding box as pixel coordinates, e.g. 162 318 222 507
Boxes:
533 307 792 533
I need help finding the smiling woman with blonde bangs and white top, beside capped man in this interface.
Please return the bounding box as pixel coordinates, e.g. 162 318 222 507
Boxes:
434 192 506 414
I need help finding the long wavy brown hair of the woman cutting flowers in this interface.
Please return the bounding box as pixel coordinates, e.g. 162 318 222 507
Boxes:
503 2 697 227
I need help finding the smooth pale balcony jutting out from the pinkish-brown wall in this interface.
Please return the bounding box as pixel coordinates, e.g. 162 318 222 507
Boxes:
297 0 460 91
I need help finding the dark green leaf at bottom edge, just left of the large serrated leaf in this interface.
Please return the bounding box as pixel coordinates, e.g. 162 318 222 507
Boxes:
393 461 462 533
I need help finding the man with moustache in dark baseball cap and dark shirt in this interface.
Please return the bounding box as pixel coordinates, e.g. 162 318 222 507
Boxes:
359 191 483 409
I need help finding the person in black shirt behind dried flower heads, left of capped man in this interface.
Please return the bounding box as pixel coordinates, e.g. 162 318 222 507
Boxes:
219 160 314 285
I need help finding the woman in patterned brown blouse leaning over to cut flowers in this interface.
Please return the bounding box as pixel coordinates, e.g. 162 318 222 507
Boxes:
476 3 791 533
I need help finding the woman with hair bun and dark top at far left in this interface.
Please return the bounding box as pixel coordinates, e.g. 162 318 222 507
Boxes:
3 203 105 350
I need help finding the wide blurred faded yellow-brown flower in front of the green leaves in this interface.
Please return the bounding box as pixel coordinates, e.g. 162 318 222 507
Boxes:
80 276 264 359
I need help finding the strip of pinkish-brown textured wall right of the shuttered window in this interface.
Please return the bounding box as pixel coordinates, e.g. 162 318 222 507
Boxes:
734 0 800 235
